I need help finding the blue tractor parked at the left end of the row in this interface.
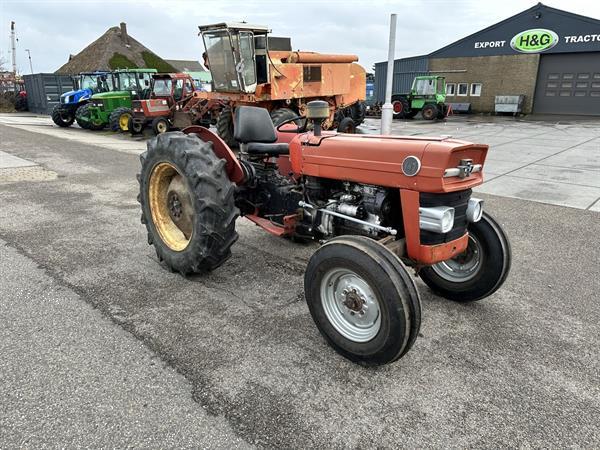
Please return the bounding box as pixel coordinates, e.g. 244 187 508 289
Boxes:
52 72 113 127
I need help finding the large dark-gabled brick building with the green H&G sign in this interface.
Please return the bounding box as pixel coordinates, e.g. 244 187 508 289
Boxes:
375 3 600 115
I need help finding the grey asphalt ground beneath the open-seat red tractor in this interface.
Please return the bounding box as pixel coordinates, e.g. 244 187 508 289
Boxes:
0 118 600 448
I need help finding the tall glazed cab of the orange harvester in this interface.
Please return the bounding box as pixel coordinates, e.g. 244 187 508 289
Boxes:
199 23 270 94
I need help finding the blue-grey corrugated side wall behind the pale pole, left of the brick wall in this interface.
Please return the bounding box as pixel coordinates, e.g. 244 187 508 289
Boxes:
375 56 429 102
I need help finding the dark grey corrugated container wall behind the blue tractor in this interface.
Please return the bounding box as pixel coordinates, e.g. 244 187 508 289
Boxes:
23 73 73 114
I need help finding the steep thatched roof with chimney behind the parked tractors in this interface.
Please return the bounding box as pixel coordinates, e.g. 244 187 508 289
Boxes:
55 22 177 75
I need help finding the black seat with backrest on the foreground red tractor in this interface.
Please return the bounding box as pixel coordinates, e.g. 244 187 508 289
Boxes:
233 106 290 156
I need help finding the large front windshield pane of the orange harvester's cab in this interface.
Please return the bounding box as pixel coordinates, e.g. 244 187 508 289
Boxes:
202 30 240 92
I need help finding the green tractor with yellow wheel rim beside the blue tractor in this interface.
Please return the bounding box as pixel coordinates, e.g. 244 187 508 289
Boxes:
75 69 156 131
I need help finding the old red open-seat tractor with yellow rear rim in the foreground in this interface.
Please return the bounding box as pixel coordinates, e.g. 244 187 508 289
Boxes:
138 101 511 365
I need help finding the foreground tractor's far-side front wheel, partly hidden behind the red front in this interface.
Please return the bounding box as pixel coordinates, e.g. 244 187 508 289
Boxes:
419 212 512 302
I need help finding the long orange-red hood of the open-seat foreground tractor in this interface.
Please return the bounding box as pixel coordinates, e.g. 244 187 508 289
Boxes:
290 132 488 192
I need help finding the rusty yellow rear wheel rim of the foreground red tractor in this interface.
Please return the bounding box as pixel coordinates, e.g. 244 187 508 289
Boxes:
148 162 194 252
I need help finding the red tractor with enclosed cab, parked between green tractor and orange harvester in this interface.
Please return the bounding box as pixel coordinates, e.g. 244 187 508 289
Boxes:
128 73 196 135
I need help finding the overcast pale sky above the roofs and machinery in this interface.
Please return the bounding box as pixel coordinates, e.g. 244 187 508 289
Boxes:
0 0 600 74
